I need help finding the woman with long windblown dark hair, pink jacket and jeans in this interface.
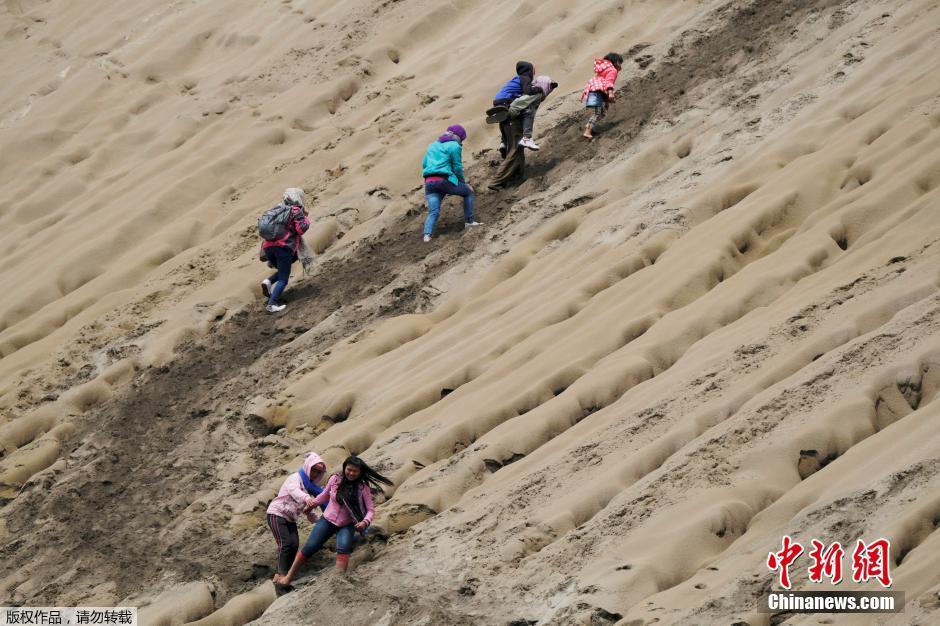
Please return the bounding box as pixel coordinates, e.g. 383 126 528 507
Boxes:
274 456 392 585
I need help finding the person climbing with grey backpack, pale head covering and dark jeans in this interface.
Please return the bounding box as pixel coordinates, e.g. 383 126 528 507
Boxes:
258 187 310 313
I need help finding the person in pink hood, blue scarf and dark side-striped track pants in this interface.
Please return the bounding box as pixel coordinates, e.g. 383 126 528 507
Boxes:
267 452 326 593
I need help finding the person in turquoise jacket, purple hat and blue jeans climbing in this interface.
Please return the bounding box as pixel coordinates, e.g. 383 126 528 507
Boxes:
421 124 481 243
